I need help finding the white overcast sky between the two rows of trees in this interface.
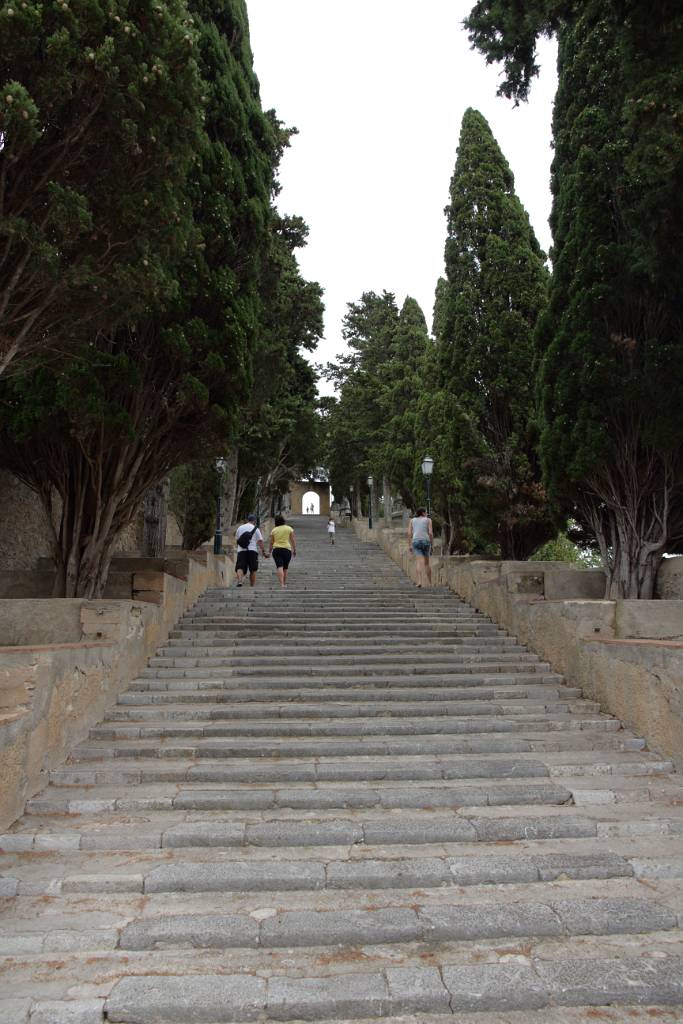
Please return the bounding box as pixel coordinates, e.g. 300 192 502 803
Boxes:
247 0 556 392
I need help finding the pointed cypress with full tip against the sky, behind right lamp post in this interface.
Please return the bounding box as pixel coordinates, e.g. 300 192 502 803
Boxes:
438 109 556 558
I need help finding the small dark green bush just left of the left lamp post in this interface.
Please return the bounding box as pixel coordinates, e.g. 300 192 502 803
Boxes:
169 459 220 551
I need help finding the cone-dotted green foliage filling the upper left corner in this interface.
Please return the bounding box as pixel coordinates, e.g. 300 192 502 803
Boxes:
0 0 204 374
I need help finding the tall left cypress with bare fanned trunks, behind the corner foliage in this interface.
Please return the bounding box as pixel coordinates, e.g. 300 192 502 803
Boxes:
0 0 275 597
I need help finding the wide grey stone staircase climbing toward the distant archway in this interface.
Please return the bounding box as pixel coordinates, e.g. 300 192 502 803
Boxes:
0 517 683 1024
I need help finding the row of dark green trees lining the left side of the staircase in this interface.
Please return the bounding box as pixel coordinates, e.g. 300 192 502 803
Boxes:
0 0 323 596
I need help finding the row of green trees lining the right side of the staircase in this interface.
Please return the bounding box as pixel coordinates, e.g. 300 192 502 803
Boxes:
326 0 683 598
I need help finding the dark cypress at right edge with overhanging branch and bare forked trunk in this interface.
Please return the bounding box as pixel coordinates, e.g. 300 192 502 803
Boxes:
469 0 683 598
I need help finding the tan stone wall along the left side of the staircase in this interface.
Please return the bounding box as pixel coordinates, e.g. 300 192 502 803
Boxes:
0 552 231 830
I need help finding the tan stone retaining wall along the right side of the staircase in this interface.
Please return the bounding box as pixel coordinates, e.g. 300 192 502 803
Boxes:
353 519 683 768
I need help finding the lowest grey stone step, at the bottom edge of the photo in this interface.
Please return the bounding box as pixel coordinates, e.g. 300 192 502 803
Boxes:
105 955 683 1024
